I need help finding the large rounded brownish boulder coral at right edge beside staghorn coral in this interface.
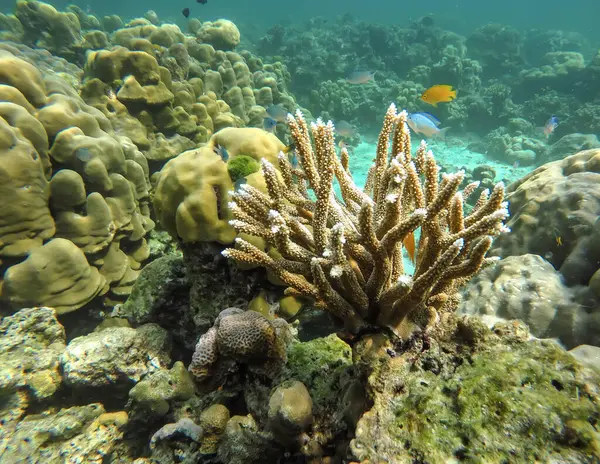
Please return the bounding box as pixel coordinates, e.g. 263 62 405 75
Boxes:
492 149 600 297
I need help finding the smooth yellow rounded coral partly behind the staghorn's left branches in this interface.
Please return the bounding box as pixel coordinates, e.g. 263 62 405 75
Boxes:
154 128 284 244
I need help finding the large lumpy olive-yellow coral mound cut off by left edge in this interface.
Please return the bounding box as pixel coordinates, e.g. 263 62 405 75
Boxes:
0 50 154 314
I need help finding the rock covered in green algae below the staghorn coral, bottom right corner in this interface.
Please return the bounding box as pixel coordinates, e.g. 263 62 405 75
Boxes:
351 318 600 463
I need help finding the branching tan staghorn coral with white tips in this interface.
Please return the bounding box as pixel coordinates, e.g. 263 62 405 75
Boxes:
223 104 508 337
